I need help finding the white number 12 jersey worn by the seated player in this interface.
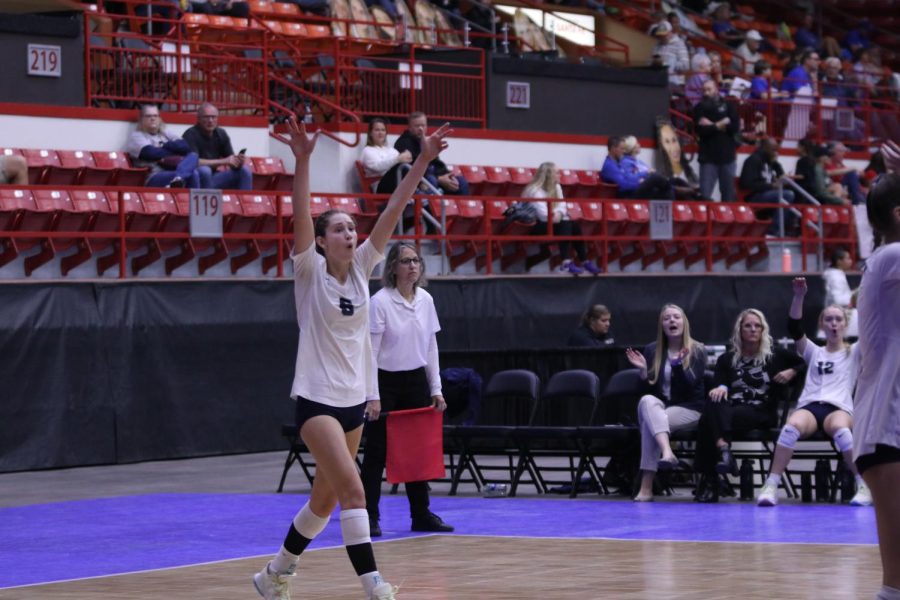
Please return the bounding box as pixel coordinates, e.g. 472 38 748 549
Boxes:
797 340 859 414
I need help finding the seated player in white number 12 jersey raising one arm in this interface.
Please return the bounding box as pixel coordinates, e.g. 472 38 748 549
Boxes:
756 277 872 506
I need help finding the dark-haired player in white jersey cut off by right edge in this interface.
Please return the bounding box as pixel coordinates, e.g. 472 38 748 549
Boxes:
854 142 900 600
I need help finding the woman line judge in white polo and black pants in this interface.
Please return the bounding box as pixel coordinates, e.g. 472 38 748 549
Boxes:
362 242 453 536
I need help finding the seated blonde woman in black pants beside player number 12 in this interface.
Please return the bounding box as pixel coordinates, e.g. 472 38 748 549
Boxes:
694 308 804 502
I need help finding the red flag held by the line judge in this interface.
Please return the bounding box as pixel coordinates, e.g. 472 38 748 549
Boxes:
386 406 445 483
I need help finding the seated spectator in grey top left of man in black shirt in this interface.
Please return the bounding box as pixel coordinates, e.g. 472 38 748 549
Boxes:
125 104 200 188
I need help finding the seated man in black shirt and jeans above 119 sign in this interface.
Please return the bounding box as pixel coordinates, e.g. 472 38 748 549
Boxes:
184 102 253 190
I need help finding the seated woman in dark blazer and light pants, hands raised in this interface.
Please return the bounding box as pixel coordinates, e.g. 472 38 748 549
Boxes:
625 304 706 502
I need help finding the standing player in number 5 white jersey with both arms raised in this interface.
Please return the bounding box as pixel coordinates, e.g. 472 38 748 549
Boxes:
253 118 450 600
